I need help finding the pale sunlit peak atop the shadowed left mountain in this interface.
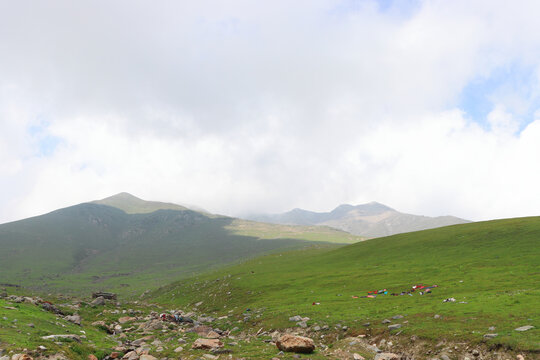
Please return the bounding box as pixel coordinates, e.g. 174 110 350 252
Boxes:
92 192 188 214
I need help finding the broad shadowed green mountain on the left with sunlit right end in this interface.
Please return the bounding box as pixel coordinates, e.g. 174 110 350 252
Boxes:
0 193 362 292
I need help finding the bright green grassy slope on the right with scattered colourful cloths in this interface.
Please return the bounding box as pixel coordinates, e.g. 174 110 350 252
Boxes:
151 217 540 351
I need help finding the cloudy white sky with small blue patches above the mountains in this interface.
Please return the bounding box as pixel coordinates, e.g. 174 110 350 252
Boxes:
0 0 540 223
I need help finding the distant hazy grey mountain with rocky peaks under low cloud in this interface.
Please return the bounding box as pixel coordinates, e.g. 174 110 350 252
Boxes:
248 202 470 238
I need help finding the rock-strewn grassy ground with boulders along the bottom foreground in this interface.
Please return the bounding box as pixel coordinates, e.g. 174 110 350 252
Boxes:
0 294 538 360
